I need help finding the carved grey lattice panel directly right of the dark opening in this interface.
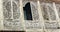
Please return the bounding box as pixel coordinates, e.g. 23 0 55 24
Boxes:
31 2 39 20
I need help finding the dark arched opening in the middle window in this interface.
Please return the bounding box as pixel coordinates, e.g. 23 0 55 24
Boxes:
23 2 33 20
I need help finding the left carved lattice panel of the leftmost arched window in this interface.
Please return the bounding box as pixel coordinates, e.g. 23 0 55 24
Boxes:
3 1 12 18
